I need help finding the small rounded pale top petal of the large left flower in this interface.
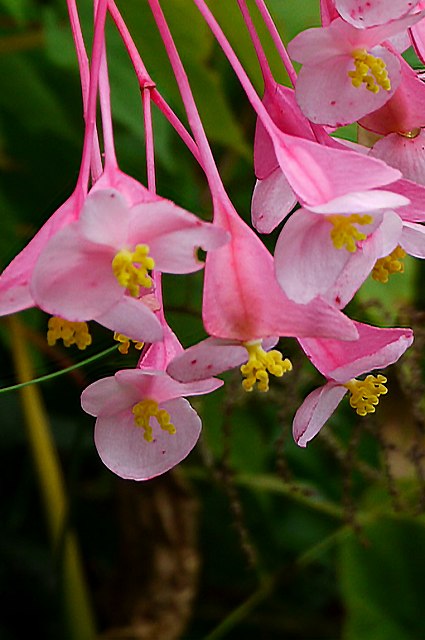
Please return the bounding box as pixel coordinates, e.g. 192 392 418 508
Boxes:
79 189 131 249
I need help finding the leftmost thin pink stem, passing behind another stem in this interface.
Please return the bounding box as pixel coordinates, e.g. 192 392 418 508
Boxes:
67 0 103 182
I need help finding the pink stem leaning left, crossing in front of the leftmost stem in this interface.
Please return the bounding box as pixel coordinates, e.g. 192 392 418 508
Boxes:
77 0 107 195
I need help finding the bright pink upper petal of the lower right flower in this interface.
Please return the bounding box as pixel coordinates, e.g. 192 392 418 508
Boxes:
299 322 413 383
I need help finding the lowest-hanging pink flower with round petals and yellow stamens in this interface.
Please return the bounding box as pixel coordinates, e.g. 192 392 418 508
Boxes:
81 327 222 480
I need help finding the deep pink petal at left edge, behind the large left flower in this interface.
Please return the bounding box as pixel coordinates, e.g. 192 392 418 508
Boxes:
0 192 79 316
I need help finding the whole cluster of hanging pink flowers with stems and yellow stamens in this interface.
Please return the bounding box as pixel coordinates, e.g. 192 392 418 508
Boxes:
0 0 425 480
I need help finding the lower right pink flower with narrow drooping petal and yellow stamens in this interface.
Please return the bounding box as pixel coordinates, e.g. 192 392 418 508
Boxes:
293 323 413 447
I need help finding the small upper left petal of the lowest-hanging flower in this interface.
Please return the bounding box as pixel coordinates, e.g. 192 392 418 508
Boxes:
81 376 139 416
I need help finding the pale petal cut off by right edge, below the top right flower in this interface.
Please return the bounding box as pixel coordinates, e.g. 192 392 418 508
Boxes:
370 130 425 185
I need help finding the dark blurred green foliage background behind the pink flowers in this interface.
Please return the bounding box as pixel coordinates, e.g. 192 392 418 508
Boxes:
0 0 425 640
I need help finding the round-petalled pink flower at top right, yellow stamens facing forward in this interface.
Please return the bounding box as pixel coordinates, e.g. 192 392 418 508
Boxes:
288 14 422 126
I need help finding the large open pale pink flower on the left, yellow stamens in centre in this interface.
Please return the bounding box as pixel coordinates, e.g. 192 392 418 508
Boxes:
31 189 226 342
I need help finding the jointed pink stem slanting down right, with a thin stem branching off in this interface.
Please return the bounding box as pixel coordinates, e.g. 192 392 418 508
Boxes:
108 0 201 164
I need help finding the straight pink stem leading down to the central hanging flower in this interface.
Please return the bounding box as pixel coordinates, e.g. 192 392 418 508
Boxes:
148 0 227 199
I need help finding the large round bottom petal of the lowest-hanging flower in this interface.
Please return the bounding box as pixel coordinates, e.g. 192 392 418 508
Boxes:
94 398 201 480
